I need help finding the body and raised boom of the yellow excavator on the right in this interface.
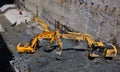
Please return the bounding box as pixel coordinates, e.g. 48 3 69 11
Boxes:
62 32 117 59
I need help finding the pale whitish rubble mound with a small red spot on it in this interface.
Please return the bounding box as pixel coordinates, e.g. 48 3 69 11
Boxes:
4 9 32 25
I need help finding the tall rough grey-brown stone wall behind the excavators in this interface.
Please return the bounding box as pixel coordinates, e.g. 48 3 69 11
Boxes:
21 0 120 47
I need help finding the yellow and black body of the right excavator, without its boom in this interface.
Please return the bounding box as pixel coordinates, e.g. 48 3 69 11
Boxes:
88 42 117 58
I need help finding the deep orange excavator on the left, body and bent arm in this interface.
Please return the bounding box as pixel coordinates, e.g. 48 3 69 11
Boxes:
17 31 62 53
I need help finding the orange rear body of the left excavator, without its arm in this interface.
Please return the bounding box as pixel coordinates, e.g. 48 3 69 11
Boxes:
17 43 35 53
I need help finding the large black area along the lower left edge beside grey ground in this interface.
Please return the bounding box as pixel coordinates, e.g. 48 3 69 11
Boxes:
0 34 13 72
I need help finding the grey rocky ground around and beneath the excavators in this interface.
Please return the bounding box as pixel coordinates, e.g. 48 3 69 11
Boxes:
0 14 120 72
